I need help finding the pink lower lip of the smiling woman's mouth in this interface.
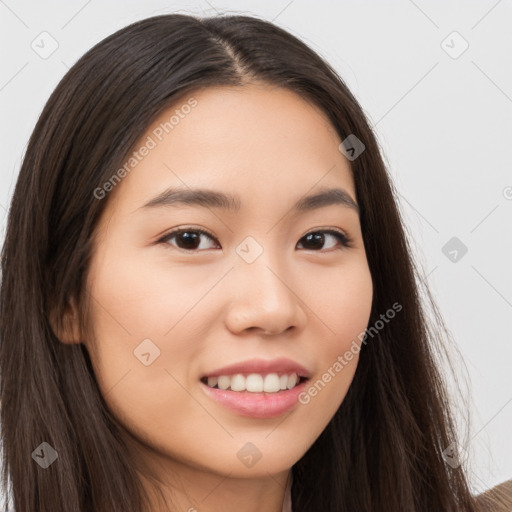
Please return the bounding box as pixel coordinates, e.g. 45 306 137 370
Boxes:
201 380 307 418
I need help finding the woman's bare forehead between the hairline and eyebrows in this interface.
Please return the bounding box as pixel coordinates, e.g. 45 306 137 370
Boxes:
103 84 355 218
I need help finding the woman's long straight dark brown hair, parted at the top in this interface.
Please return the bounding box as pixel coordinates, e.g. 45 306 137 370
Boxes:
0 14 475 512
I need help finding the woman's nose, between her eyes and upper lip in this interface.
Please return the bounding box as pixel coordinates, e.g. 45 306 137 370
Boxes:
225 251 307 335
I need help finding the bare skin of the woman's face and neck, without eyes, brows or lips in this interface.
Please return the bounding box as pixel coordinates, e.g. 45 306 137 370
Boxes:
61 84 373 512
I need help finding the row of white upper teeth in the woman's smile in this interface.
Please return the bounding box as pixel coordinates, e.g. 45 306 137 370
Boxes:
208 373 299 393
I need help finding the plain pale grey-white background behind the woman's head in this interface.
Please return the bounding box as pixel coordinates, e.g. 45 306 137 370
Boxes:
0 0 512 504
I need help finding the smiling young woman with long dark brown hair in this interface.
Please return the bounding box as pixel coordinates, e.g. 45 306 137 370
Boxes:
0 11 504 512
